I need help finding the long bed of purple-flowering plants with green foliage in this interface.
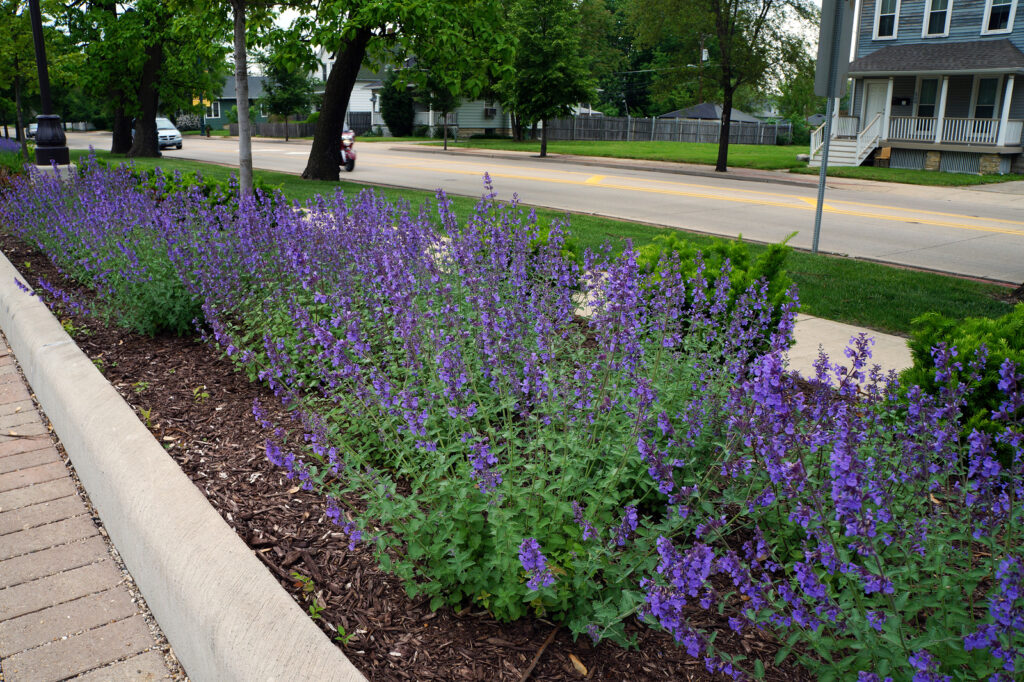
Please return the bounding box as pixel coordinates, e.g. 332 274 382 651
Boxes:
0 160 1024 679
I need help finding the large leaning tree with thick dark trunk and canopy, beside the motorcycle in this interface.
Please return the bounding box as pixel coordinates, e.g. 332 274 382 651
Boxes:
284 0 508 180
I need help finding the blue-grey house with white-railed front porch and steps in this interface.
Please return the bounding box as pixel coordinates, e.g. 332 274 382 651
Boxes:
811 0 1024 173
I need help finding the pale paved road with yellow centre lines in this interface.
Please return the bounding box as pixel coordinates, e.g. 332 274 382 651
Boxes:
69 133 1024 284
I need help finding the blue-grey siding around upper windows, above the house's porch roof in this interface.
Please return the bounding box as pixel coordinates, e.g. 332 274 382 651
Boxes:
857 0 1024 58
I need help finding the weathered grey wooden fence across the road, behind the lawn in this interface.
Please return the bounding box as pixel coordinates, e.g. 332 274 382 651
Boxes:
548 116 793 144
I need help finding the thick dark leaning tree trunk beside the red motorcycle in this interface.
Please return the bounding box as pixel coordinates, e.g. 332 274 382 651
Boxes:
302 29 373 181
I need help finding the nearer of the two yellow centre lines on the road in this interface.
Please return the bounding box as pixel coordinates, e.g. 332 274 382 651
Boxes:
382 164 1024 237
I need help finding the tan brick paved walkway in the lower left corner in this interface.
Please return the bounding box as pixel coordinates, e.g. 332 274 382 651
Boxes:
0 335 184 682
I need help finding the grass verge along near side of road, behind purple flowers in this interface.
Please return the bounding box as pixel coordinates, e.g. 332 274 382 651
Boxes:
72 151 1012 334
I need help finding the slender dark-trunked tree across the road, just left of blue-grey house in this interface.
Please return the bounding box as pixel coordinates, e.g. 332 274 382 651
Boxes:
633 0 814 172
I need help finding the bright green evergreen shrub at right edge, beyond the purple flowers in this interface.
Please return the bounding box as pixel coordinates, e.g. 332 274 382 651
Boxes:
900 303 1024 446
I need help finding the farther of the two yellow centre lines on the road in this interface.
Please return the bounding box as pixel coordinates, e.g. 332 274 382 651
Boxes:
378 156 1024 227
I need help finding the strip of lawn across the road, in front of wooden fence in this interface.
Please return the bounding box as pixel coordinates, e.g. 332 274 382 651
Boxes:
437 139 807 170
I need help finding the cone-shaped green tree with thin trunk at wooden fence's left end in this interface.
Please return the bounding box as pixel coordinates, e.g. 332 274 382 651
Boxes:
508 0 594 157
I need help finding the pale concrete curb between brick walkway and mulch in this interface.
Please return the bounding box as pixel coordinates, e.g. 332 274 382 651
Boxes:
0 249 365 682
